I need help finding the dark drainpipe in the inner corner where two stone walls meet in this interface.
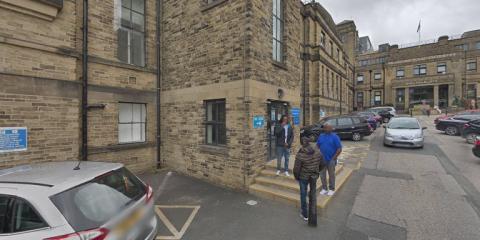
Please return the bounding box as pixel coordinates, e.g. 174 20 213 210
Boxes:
155 0 162 169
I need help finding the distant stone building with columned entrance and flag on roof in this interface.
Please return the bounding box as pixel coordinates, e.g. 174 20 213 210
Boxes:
355 30 480 110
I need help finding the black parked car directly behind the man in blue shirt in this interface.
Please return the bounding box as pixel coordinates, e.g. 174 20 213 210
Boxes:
300 115 373 141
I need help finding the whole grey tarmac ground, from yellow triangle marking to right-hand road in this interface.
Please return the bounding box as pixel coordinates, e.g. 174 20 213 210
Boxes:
141 116 480 240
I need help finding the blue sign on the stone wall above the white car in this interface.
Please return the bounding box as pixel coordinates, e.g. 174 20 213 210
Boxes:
0 127 28 153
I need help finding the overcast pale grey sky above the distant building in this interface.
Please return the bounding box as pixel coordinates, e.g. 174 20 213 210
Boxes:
310 0 480 48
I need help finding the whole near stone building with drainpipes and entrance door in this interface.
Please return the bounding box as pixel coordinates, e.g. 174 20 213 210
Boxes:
0 0 356 189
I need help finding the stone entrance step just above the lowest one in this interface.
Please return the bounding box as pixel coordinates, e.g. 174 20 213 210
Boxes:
255 165 344 193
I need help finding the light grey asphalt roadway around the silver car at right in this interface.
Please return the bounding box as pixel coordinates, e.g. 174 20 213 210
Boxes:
347 117 480 240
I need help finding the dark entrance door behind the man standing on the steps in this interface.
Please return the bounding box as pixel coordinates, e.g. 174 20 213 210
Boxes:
267 101 288 161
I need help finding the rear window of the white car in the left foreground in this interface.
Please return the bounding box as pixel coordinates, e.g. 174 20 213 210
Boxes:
50 168 146 231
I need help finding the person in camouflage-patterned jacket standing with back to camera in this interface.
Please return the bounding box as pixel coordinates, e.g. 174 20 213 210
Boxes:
293 137 324 226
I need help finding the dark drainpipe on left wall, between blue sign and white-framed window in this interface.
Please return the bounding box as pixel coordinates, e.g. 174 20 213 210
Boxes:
82 0 88 161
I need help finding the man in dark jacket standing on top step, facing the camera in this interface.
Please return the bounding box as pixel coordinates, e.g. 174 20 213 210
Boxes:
275 116 293 177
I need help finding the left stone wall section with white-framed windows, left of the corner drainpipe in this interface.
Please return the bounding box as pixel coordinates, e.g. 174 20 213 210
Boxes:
0 0 161 171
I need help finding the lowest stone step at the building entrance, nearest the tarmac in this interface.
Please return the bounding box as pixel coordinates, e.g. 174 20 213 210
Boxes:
249 168 353 208
